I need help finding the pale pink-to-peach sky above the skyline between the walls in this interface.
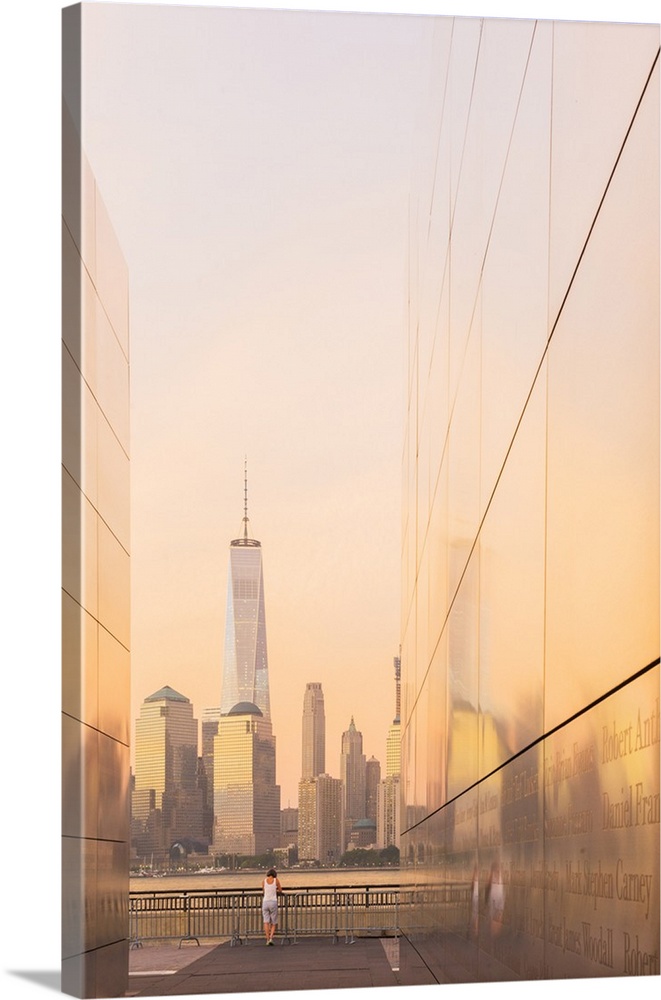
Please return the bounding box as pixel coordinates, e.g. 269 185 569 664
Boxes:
76 4 431 806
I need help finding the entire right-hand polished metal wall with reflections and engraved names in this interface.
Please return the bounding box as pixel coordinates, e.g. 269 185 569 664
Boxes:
401 18 660 982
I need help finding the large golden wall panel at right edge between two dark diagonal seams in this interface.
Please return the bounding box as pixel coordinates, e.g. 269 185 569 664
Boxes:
545 52 659 729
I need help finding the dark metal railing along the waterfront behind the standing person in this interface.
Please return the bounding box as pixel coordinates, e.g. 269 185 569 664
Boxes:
129 885 408 948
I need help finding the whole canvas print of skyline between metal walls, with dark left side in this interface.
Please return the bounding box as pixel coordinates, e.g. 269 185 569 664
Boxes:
62 2 660 997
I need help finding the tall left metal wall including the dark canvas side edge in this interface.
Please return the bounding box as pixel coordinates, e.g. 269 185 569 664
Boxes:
62 6 130 997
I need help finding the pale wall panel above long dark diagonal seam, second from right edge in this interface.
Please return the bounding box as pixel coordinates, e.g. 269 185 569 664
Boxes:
480 24 553 514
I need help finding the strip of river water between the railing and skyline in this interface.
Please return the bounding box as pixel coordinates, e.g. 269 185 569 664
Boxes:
130 868 400 892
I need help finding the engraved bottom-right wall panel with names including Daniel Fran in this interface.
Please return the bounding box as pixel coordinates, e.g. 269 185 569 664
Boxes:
544 667 660 978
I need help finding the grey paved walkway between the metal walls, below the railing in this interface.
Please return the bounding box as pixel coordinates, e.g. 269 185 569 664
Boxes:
127 938 436 997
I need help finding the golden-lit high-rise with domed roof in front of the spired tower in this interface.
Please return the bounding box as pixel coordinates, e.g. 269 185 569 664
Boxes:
213 702 280 854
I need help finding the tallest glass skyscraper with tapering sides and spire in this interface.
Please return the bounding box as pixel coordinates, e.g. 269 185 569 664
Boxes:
220 474 271 719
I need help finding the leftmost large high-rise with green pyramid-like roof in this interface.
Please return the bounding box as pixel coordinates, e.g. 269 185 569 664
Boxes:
132 685 204 854
